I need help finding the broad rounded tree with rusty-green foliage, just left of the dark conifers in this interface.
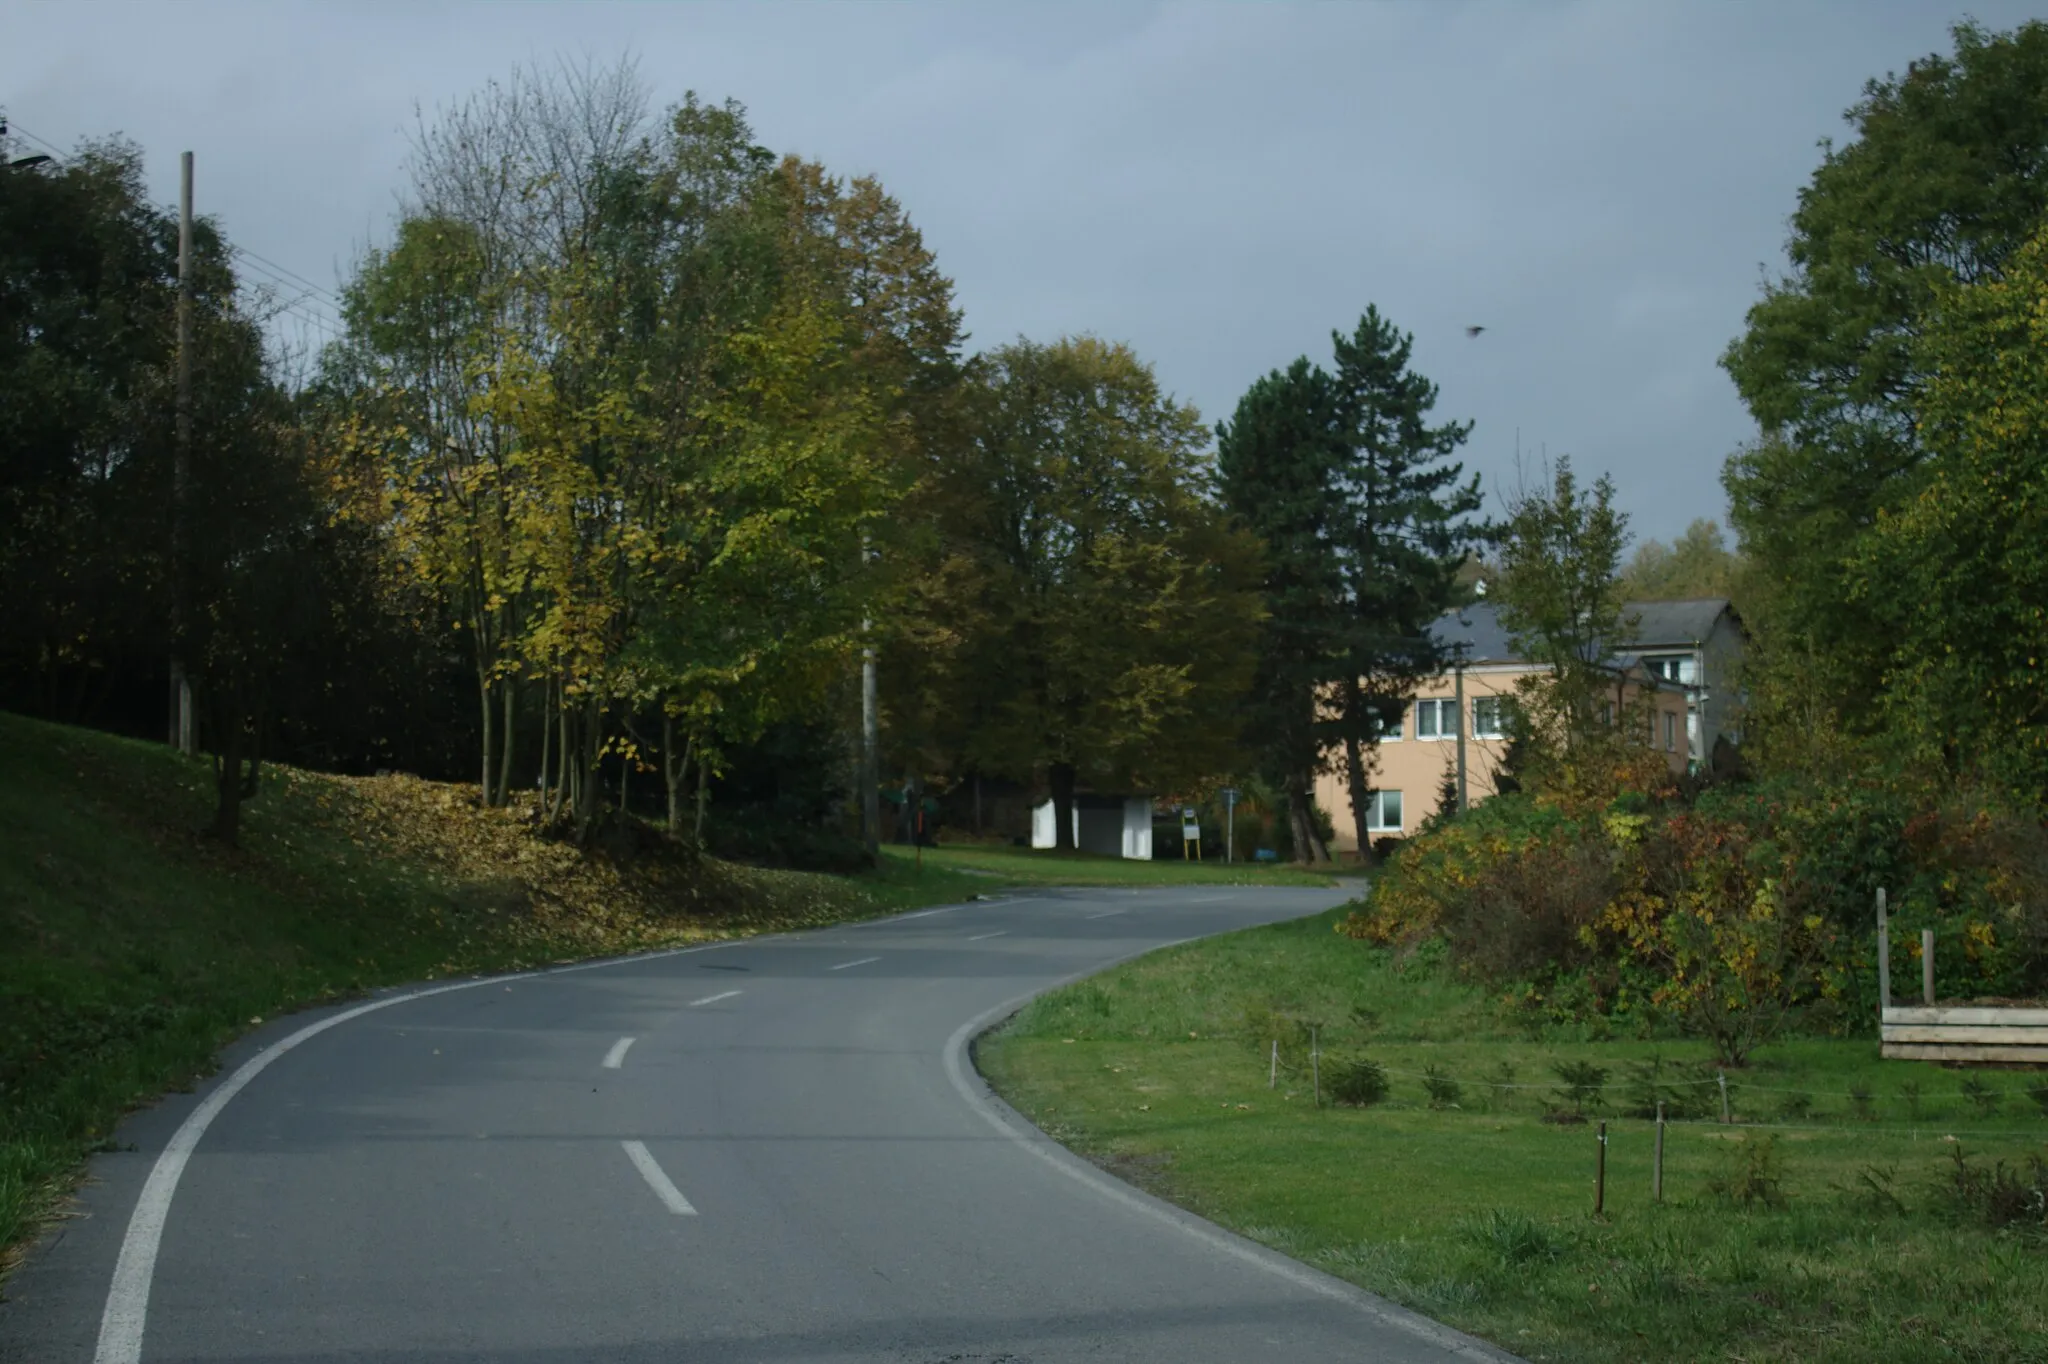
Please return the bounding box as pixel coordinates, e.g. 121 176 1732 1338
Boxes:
944 338 1257 848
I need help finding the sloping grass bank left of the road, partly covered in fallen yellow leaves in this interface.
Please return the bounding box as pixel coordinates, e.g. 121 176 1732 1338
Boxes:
0 715 991 1270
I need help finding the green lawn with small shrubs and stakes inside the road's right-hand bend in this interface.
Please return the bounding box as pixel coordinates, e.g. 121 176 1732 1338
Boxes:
977 911 2048 1364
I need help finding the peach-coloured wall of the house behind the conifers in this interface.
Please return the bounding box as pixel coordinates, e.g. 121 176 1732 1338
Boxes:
1315 664 1688 856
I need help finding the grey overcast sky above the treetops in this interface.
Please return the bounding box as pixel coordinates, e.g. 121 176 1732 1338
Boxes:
0 0 2048 539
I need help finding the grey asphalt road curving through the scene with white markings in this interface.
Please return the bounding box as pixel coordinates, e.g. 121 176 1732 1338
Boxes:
0 887 1507 1364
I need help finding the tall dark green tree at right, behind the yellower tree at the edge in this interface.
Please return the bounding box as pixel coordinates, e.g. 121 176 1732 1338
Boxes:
1722 20 2048 729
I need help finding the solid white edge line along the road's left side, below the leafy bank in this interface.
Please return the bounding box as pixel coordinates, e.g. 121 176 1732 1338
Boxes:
92 938 754 1364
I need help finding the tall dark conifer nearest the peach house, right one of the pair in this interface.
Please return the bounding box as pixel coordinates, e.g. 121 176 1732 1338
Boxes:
1331 307 1483 858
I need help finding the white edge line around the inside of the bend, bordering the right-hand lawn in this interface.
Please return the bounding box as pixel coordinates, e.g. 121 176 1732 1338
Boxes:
942 954 1518 1364
